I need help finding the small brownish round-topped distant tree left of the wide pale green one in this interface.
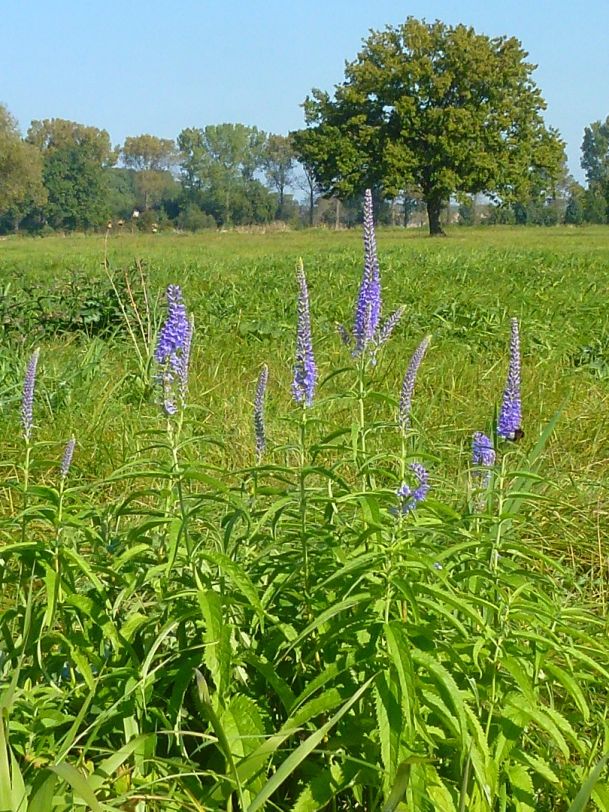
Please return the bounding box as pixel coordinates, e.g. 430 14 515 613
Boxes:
121 135 179 211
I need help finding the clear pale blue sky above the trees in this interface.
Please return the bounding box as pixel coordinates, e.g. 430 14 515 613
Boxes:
0 0 609 178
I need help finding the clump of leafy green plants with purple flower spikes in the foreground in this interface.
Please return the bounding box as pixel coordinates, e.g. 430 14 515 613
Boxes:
0 235 609 812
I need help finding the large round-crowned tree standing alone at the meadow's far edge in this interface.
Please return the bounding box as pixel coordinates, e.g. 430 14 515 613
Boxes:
293 17 563 234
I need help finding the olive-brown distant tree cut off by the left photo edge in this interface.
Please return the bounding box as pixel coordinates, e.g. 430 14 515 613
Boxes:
0 104 46 229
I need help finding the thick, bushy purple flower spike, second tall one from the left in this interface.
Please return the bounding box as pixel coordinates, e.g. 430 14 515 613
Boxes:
154 285 193 415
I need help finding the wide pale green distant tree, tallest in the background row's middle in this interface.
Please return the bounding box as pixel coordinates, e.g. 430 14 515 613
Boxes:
178 124 266 225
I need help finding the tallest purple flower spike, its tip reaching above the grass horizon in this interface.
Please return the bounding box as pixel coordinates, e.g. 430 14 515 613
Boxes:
353 189 381 356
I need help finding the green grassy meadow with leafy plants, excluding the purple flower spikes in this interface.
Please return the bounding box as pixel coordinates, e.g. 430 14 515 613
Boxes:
0 227 609 812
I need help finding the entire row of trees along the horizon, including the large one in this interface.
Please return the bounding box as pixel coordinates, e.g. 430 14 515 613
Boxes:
0 17 609 235
